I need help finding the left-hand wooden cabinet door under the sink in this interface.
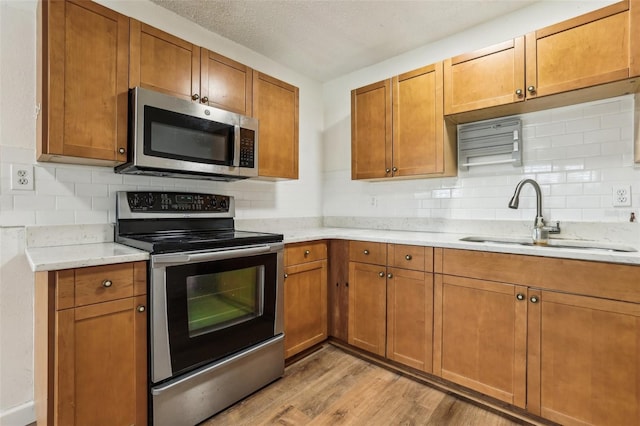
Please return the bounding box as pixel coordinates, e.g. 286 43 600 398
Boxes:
433 275 527 408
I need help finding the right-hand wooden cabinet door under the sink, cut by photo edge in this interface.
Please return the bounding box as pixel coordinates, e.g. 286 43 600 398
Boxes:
527 291 640 425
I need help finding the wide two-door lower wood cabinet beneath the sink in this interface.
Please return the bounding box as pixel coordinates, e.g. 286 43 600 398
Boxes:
433 249 640 425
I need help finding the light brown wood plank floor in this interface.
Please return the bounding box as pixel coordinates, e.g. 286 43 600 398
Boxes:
200 344 523 426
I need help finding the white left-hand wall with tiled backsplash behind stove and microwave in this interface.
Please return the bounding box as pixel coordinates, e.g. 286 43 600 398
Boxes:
0 0 323 425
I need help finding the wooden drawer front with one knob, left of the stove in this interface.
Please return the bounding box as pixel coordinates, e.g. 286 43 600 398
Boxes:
56 263 136 310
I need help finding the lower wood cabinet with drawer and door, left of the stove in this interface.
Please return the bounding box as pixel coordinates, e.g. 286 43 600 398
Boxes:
35 262 147 426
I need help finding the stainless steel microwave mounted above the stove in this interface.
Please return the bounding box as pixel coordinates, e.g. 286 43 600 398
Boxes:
115 87 258 181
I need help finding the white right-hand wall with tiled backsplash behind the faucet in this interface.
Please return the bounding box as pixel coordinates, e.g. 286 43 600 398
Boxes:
323 1 640 223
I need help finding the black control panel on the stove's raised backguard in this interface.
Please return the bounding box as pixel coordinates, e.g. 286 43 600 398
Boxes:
127 192 231 213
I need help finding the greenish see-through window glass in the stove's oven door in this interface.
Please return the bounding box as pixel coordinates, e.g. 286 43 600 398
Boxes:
187 266 264 337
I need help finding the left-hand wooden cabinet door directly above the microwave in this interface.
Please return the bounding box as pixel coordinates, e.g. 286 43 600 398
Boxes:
129 19 200 100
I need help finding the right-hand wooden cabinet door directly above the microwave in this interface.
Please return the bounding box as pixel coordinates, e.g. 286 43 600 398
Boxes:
200 49 253 116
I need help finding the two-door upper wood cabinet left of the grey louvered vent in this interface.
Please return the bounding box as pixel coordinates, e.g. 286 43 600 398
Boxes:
351 63 455 179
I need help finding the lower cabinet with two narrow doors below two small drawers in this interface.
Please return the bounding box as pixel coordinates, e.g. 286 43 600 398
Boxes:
348 241 433 372
